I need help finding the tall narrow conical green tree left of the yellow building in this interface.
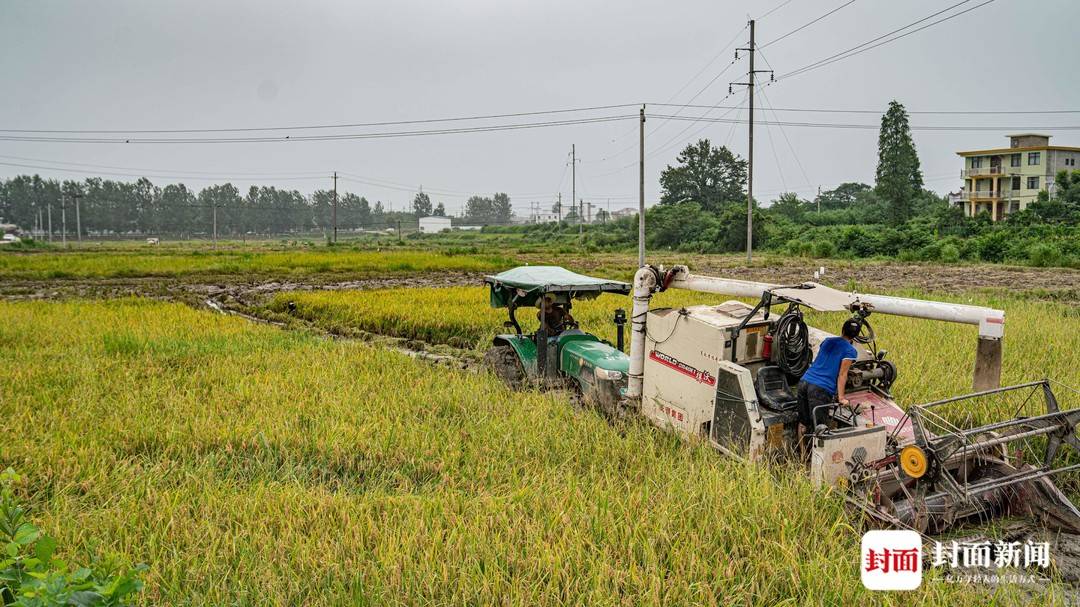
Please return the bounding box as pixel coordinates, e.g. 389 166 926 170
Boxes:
875 100 922 225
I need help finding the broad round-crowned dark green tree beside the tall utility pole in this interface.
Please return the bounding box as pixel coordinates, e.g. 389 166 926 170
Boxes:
660 139 746 213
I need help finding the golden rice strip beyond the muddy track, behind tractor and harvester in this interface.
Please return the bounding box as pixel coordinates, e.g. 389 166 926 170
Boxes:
268 284 1080 414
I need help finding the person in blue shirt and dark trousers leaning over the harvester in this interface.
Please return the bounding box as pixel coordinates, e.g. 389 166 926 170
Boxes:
798 319 862 431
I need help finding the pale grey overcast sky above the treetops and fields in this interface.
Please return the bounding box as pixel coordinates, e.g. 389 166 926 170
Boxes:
0 0 1080 214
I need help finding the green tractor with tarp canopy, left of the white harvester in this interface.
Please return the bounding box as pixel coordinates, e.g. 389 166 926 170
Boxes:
484 266 632 412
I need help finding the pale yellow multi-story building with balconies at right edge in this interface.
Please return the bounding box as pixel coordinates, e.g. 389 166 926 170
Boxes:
951 133 1080 221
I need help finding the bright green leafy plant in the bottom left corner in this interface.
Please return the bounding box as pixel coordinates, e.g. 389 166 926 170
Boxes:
0 469 146 607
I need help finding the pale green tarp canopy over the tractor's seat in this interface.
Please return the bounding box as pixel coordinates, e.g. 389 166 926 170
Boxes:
484 266 632 308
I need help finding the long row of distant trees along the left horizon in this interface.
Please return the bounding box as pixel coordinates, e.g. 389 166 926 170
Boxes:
0 175 512 237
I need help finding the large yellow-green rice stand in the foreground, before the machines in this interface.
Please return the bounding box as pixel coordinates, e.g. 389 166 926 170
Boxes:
0 300 1045 606
